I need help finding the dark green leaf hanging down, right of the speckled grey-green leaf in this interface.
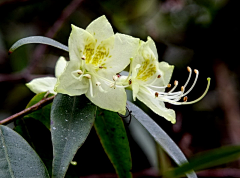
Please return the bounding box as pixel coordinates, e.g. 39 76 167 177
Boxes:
94 108 132 178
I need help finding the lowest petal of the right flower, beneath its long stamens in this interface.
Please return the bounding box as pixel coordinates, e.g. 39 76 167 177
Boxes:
137 91 176 124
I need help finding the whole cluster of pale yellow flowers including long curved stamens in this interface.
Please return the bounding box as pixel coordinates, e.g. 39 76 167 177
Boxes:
27 16 210 123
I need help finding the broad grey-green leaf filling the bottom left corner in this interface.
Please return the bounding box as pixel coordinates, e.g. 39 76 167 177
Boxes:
0 125 49 178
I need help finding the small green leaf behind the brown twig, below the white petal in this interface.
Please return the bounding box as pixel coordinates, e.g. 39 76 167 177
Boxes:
25 92 53 129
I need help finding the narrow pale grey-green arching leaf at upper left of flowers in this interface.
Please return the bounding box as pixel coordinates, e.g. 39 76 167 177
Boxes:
9 36 68 53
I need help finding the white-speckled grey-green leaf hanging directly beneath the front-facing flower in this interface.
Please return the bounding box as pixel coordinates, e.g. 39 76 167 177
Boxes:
51 93 97 178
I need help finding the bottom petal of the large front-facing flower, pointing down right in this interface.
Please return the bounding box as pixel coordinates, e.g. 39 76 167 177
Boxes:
86 76 127 115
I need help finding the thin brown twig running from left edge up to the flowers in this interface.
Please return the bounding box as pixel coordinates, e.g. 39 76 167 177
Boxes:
0 95 55 125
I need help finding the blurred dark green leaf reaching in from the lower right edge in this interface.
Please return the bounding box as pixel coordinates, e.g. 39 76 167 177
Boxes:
166 146 240 177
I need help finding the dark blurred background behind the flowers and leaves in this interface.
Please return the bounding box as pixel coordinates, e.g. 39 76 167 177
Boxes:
0 0 240 177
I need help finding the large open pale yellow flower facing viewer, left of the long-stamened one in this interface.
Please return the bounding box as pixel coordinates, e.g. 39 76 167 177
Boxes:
55 16 140 114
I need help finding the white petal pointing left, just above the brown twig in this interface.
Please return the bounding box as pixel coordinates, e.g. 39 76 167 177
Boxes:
26 77 57 94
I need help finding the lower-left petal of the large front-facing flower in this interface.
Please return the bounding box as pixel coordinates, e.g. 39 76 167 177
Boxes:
55 61 89 96
